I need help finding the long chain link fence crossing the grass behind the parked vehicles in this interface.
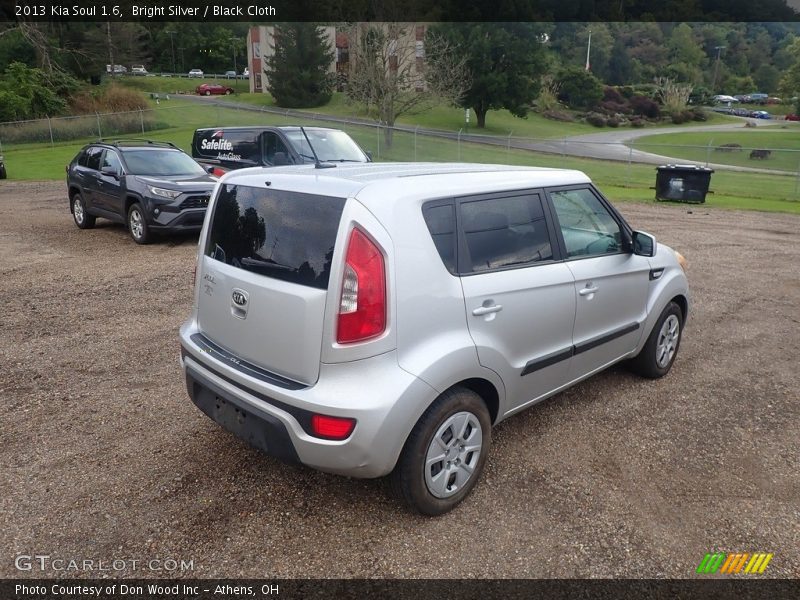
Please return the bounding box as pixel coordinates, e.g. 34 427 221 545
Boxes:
0 103 800 200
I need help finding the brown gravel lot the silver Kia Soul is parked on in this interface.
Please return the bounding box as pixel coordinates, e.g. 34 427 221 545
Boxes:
0 182 800 578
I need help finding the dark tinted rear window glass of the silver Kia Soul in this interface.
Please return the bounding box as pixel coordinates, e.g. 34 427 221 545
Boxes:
205 185 345 289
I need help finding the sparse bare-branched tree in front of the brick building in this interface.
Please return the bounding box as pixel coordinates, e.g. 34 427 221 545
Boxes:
346 22 469 146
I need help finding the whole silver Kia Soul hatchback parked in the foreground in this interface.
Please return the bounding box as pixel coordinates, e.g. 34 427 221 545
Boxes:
180 163 689 515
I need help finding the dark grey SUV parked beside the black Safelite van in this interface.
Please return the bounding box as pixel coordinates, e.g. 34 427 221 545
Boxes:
67 139 216 244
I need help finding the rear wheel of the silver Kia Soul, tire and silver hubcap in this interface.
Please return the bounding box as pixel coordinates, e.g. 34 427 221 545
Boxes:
390 388 492 516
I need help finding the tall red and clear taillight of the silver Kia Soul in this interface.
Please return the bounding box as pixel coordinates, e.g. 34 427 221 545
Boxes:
336 229 386 344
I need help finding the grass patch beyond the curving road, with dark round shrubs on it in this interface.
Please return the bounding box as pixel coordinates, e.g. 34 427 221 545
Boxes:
630 121 800 173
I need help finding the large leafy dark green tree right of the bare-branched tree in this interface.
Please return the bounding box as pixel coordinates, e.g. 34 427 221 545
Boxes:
431 23 546 128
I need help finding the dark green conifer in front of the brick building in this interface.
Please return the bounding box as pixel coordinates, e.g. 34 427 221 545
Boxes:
264 23 334 108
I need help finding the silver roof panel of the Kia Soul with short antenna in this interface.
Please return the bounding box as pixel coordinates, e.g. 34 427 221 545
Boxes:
220 163 591 204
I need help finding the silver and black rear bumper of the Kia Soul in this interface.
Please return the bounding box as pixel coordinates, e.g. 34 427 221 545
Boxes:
180 321 438 478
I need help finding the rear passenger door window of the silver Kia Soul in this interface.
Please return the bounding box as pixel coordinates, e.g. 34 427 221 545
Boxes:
460 194 553 273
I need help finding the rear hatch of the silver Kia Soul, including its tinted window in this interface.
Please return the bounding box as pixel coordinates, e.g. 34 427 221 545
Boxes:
198 184 345 385
